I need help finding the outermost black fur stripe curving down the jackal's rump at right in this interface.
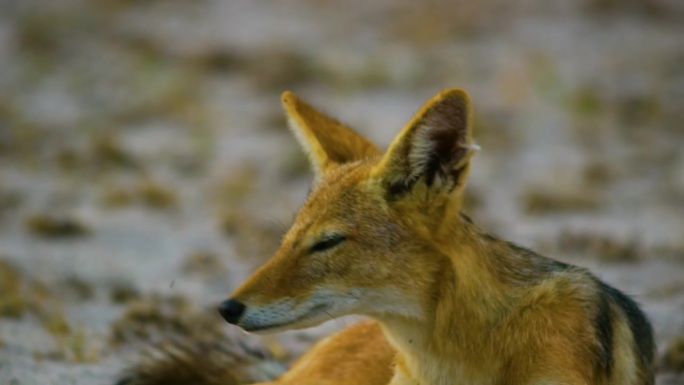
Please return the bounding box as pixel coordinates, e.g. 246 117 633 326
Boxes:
598 280 655 384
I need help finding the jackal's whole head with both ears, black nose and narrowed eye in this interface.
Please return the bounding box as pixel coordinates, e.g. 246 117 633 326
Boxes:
219 89 477 332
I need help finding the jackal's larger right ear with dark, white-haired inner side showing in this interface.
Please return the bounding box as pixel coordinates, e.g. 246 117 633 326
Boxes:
376 88 479 196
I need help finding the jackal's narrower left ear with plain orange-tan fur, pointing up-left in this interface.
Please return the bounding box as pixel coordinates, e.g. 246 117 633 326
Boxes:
281 91 381 180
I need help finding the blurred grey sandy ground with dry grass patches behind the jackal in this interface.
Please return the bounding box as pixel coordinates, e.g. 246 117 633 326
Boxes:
0 0 684 384
